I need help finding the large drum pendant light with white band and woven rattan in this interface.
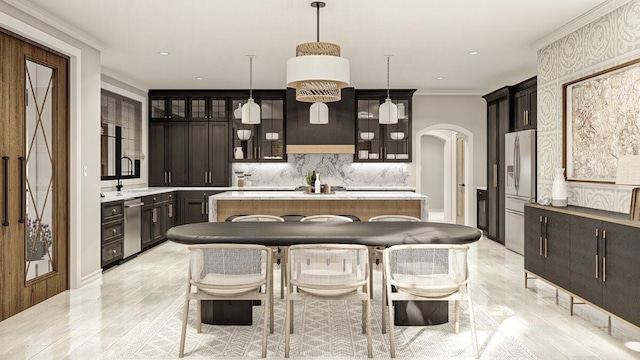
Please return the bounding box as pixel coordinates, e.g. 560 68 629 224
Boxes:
287 1 349 103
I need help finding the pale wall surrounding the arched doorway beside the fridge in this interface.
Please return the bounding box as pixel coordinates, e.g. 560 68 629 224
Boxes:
411 95 484 191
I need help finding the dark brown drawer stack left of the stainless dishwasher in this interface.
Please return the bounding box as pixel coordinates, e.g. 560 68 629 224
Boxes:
100 201 124 268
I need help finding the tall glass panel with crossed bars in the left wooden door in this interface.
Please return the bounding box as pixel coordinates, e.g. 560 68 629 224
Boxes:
20 60 58 281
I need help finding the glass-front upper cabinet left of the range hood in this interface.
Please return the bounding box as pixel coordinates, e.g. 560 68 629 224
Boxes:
231 90 286 162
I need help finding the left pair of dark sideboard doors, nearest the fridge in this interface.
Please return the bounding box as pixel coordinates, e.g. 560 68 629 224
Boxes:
524 207 572 290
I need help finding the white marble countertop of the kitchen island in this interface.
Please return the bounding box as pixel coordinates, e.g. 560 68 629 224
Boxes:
209 191 428 200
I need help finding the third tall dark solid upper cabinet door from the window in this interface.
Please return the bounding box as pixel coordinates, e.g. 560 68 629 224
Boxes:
189 122 209 186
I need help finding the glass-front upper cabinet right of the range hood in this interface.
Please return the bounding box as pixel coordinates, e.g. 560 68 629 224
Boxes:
355 90 415 162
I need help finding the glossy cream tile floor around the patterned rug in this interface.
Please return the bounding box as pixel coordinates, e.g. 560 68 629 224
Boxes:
0 229 640 359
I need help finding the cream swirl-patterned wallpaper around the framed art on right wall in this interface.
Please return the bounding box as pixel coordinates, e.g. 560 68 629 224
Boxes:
537 0 640 213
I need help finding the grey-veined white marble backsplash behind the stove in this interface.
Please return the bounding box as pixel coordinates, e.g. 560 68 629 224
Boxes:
231 154 409 187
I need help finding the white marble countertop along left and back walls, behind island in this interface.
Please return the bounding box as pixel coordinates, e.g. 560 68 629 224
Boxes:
100 186 415 203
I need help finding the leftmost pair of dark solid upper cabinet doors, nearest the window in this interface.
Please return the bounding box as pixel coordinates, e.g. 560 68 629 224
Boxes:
149 122 189 186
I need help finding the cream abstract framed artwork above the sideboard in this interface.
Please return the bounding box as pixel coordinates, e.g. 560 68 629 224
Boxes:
562 59 640 183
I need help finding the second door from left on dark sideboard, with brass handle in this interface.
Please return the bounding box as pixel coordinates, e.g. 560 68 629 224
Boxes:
543 212 571 290
